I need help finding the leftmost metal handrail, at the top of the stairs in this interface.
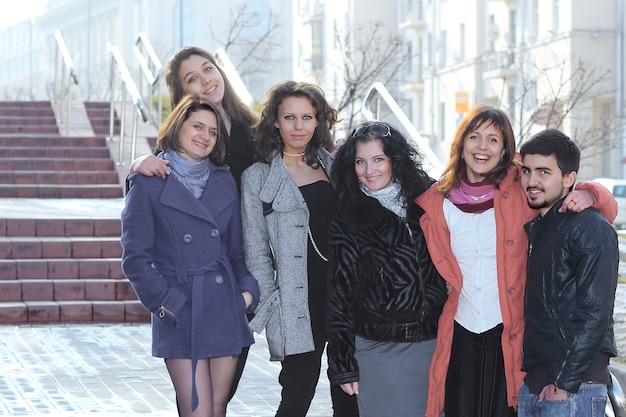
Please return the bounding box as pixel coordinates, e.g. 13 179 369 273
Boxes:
54 30 78 136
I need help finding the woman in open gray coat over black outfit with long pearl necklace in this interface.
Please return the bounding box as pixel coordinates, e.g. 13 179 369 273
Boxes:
242 81 358 417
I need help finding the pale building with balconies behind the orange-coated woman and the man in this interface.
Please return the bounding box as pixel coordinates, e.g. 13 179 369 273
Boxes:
400 0 626 179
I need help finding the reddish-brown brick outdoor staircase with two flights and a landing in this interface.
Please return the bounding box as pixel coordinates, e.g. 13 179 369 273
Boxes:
0 101 149 324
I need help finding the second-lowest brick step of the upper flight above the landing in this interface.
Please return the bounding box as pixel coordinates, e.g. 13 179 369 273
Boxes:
0 171 119 184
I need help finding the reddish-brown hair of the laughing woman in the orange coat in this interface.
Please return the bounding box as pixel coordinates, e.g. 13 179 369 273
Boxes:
437 104 515 194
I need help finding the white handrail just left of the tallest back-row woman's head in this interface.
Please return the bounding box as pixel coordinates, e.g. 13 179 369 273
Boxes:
133 32 163 127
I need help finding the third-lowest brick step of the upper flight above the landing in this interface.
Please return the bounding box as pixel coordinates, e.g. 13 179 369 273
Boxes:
0 158 115 171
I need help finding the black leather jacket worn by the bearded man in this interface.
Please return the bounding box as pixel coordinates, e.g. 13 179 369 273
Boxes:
522 200 619 392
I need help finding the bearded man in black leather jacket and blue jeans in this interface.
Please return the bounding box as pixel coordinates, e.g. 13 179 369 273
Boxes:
519 129 619 417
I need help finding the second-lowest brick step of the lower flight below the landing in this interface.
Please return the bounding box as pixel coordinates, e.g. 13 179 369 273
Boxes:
0 279 137 303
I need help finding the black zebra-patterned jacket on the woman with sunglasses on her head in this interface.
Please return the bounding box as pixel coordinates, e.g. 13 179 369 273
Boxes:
328 195 447 384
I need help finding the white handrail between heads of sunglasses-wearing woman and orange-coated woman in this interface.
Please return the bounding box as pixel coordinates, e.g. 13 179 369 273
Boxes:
361 82 444 179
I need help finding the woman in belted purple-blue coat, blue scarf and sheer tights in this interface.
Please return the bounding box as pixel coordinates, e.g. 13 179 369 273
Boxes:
122 96 259 417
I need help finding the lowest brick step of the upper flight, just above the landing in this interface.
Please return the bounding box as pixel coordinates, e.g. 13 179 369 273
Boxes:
0 183 124 198
